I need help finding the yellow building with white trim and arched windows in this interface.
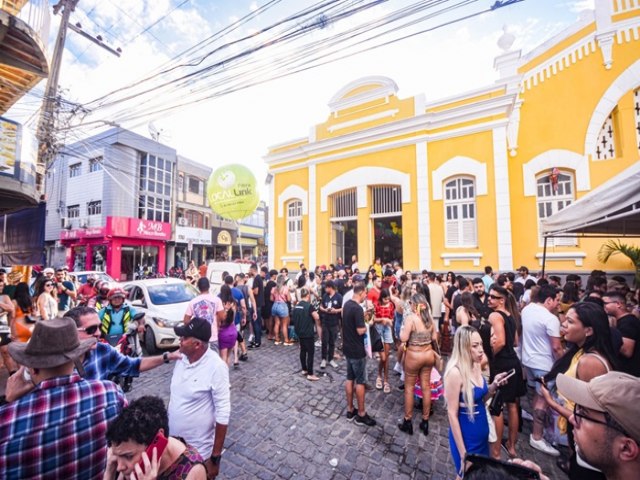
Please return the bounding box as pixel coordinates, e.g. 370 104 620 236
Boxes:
265 0 640 271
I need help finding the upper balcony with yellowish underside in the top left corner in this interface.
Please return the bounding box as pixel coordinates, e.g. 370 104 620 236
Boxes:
0 0 50 115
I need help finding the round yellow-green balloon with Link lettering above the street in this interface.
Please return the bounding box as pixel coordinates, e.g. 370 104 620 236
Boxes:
207 164 260 220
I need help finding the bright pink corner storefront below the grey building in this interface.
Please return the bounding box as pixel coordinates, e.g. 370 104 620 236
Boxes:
60 217 171 281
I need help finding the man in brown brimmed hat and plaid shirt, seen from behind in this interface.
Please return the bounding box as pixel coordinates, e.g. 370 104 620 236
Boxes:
0 318 126 479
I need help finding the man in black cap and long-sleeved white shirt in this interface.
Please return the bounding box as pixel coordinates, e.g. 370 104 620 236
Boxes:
168 317 231 478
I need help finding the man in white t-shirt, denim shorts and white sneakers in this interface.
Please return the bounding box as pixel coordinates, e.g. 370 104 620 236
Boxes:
522 285 562 456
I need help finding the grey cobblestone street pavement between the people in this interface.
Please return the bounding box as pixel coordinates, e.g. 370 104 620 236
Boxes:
128 342 566 480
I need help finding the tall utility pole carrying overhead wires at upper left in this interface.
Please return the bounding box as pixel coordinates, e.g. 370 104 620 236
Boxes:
36 0 79 198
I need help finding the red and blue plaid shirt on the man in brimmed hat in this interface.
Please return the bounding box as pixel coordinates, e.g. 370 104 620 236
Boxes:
0 373 127 480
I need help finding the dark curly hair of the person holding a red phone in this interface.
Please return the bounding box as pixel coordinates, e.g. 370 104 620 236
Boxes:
107 396 169 446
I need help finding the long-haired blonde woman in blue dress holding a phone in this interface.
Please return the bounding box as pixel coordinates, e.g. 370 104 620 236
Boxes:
444 325 507 478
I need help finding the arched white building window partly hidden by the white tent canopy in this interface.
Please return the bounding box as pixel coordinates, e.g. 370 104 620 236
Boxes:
536 171 576 247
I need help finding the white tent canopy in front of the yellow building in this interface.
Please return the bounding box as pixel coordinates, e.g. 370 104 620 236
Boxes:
542 161 640 237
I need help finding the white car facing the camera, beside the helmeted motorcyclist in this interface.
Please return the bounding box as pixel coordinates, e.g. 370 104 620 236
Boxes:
122 278 198 355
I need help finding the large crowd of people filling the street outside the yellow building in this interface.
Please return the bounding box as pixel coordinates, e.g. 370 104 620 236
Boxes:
0 258 640 480
